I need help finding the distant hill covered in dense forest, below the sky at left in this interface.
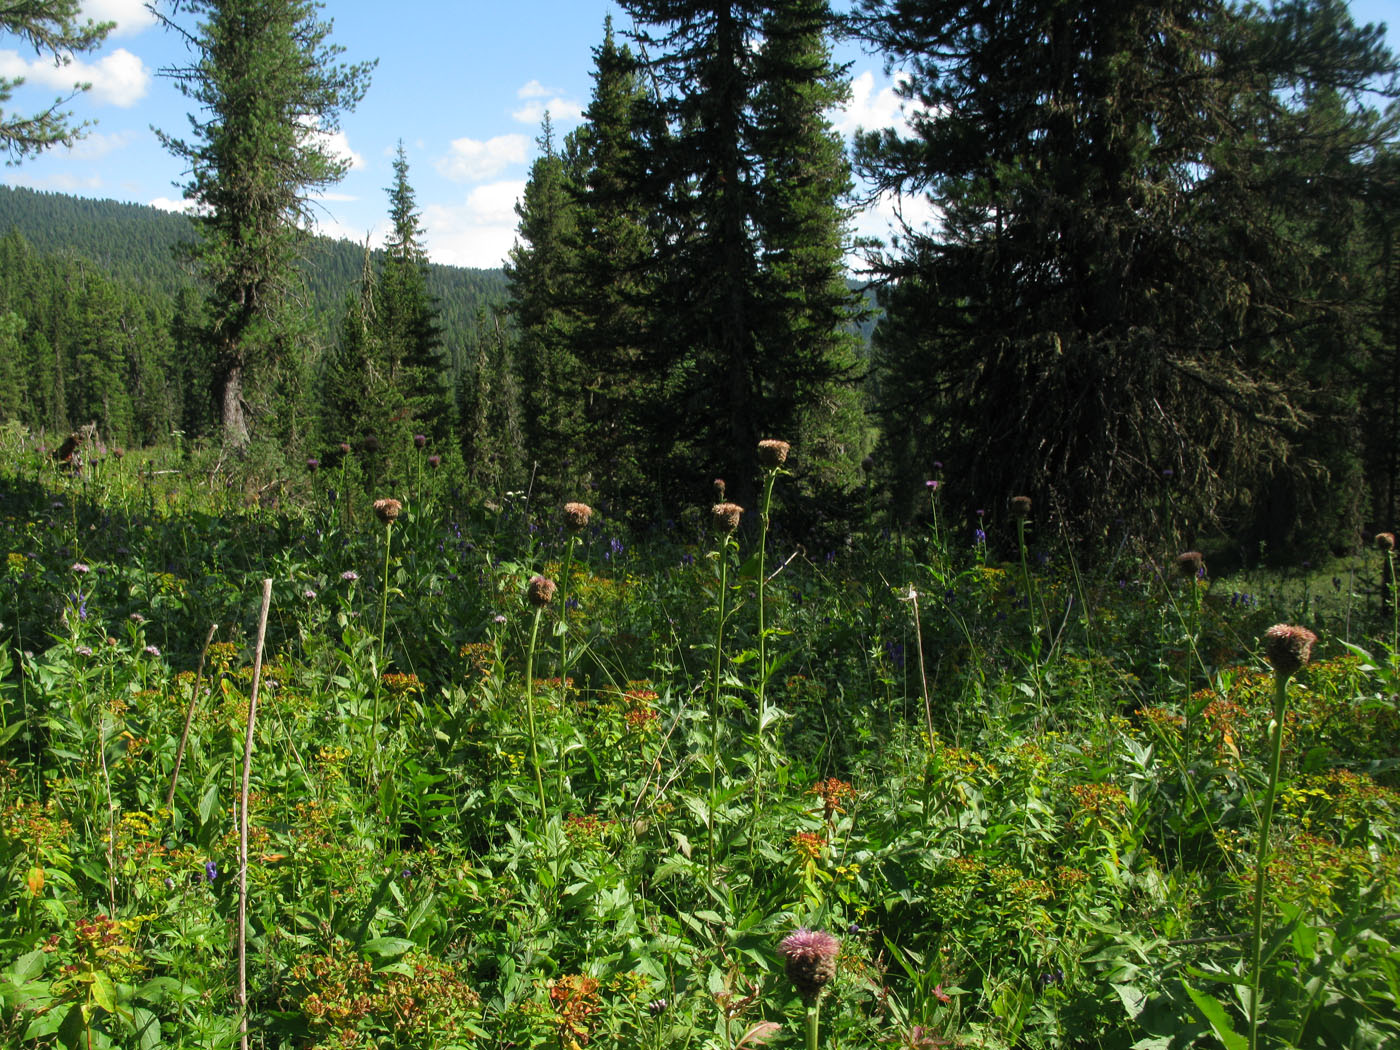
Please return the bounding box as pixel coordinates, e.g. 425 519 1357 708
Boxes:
0 186 505 333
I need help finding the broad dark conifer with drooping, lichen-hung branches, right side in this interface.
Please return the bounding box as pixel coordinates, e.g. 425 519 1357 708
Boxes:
858 0 1393 554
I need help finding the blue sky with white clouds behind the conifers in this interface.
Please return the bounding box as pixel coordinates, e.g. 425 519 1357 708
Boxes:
0 0 1400 267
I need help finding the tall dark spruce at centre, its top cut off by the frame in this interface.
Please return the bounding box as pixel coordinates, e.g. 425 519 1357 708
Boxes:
622 0 860 503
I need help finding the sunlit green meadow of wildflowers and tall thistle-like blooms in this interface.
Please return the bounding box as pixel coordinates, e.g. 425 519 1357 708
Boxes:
0 428 1400 1050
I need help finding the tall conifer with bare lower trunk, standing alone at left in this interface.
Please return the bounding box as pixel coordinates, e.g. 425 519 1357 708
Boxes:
158 0 372 447
